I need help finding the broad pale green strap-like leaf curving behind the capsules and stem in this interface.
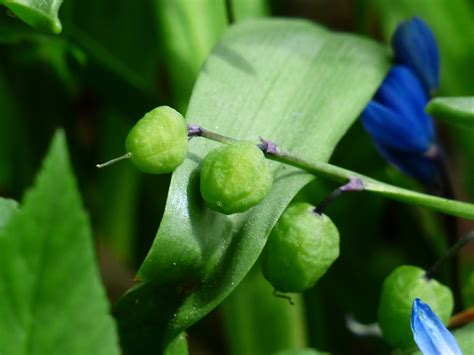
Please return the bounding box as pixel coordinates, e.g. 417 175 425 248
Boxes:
116 20 389 353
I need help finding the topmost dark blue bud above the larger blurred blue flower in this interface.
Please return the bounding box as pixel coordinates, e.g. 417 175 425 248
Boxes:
392 17 440 94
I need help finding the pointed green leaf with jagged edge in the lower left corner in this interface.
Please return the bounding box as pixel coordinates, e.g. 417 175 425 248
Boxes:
0 132 119 355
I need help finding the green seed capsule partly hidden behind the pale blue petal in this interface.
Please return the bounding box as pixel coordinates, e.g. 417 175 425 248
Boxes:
378 265 453 349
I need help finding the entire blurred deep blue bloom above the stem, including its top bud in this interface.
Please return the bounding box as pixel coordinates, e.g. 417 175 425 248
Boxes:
361 17 449 188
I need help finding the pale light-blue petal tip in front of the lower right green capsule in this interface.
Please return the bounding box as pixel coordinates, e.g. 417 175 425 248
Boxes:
411 298 462 355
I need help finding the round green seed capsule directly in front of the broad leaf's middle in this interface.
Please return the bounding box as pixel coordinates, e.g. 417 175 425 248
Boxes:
201 142 273 214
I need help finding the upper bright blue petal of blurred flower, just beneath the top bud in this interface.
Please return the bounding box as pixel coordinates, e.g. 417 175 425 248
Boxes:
374 65 435 143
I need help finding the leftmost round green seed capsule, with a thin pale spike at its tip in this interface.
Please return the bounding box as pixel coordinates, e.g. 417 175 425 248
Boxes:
125 106 188 174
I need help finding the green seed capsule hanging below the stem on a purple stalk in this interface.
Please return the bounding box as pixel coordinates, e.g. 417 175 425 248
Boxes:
262 202 339 292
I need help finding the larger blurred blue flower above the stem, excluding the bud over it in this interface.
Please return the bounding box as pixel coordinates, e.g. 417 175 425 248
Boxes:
361 65 439 184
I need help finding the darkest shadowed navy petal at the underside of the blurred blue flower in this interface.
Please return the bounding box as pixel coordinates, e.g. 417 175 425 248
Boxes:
375 144 439 186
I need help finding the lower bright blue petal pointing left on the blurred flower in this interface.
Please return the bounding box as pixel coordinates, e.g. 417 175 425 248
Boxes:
361 101 432 155
